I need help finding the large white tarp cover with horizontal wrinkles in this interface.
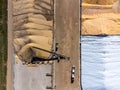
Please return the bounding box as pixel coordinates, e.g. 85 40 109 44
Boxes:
81 36 120 90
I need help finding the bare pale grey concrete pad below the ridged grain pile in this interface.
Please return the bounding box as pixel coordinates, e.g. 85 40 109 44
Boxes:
14 61 51 90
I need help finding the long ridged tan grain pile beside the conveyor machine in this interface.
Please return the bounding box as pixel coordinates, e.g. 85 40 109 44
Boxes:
13 0 53 62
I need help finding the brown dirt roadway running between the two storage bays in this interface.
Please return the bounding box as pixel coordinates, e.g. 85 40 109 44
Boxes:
53 0 80 90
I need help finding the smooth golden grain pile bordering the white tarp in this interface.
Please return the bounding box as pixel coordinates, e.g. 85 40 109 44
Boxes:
82 0 120 35
